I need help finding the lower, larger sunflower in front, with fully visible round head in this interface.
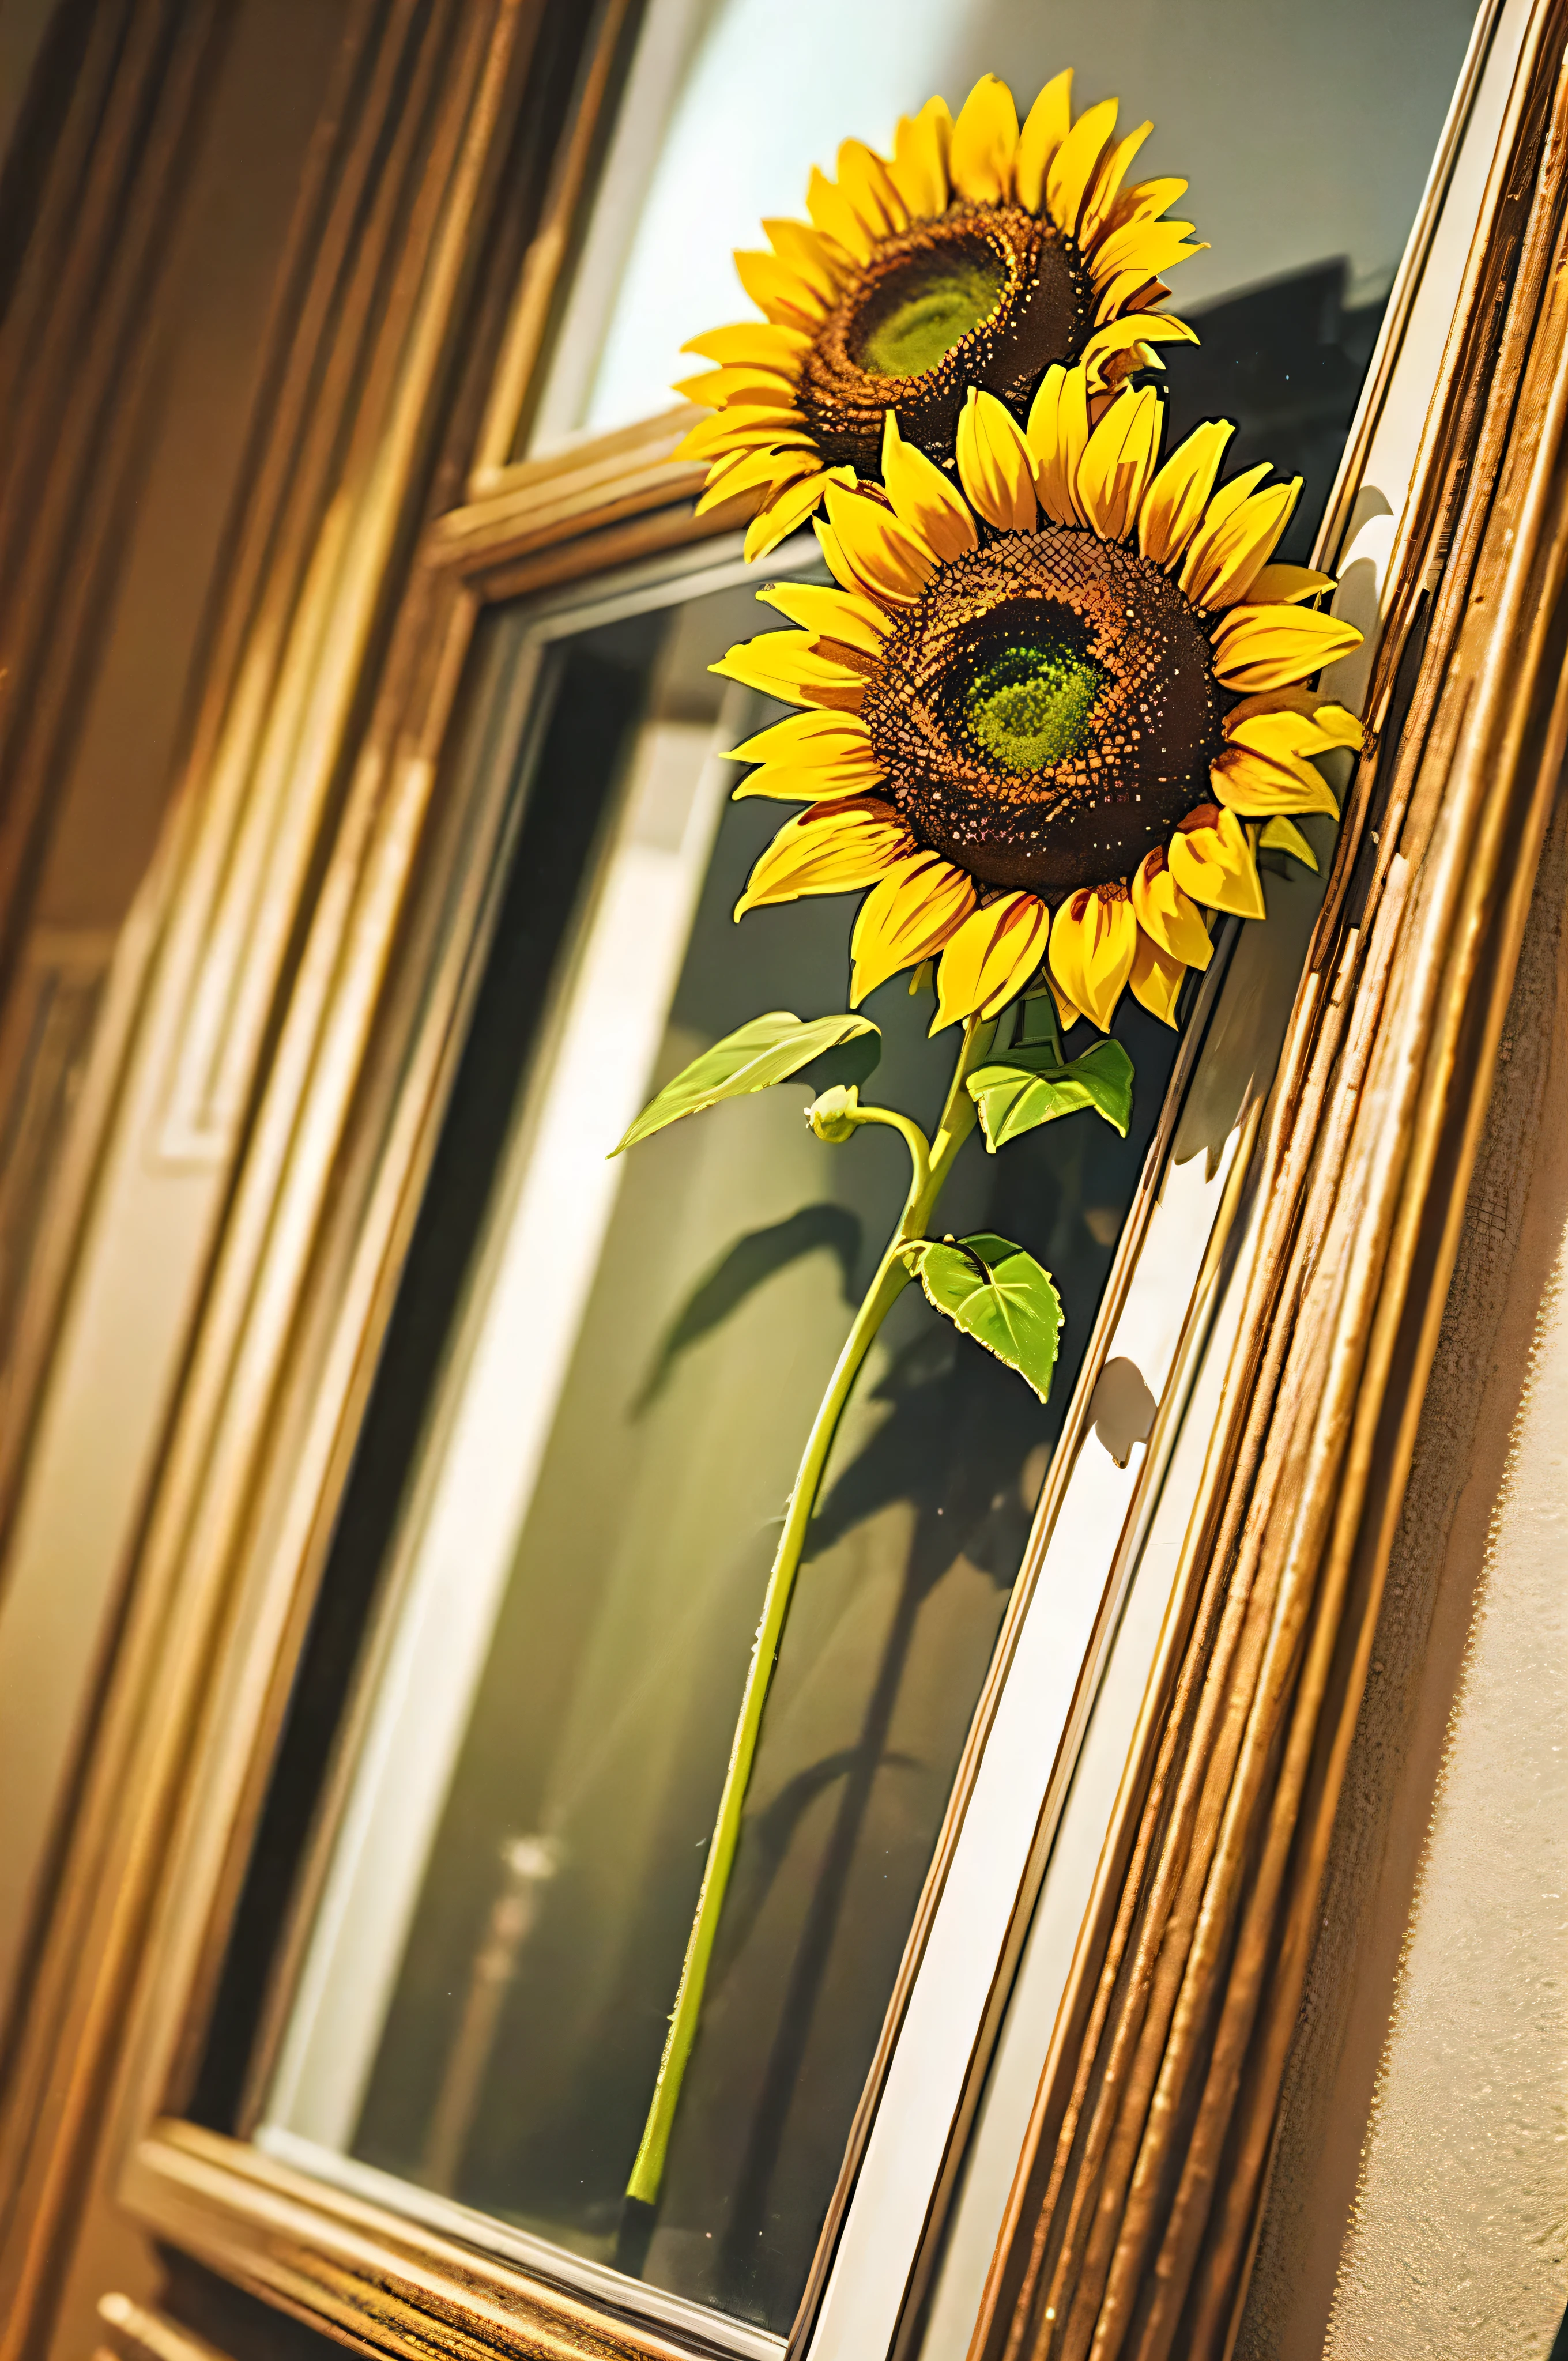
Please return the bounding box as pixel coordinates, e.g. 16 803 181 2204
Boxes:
713 364 1365 1029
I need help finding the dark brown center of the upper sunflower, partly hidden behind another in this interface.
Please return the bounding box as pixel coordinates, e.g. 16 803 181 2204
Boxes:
801 205 1088 474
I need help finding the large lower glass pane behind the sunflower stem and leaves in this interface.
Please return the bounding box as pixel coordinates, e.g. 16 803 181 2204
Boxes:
262 557 1176 2333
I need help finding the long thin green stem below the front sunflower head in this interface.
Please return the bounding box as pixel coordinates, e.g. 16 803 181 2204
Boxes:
626 1017 997 2205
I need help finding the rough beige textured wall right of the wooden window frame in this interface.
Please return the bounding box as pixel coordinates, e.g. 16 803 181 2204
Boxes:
1238 805 1568 2361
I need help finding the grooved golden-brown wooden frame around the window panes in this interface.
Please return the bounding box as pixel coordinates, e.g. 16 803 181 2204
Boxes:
0 0 1568 2361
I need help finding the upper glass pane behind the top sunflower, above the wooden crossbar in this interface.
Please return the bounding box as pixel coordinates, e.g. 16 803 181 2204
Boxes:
529 0 1476 481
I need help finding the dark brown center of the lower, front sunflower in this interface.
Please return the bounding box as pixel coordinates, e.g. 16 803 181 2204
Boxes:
862 524 1221 897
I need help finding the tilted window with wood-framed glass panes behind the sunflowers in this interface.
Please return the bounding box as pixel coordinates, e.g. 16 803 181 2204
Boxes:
27 0 1544 2361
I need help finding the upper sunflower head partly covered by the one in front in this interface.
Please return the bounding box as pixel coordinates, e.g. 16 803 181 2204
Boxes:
676 73 1202 557
